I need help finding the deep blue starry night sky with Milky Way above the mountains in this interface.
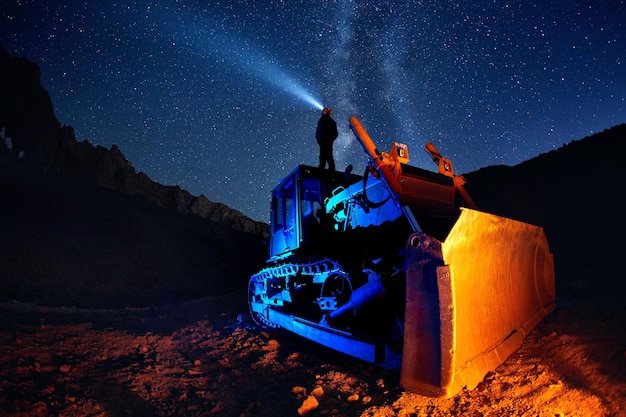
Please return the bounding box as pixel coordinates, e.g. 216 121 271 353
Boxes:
0 0 626 221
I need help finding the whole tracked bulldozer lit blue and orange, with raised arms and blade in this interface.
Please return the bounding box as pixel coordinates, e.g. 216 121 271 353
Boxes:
248 116 555 398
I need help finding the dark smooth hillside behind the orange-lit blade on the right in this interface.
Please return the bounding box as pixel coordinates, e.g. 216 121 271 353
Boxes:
465 124 626 303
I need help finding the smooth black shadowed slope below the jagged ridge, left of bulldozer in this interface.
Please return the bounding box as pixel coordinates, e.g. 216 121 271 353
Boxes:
0 154 267 308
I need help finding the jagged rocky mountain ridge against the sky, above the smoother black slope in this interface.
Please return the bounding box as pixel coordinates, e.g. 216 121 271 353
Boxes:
0 48 268 237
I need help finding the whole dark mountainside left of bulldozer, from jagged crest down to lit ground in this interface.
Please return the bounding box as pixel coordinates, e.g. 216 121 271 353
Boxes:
0 49 268 308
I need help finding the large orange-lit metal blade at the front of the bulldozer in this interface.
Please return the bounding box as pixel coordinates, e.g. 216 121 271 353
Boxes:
400 208 555 398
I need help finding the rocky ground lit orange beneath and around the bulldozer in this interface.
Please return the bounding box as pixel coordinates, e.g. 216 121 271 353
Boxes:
0 293 626 417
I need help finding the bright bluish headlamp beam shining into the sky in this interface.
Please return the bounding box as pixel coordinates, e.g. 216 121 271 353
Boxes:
176 19 324 110
